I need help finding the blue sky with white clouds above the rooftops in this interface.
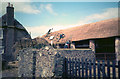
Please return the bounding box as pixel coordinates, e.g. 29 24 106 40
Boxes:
0 0 118 38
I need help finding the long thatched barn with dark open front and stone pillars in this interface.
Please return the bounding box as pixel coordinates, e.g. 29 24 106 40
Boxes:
43 18 120 60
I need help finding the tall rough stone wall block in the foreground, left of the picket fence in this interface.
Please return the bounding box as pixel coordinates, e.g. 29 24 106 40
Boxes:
18 46 64 77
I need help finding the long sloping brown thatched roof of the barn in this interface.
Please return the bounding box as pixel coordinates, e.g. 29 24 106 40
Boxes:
42 18 120 43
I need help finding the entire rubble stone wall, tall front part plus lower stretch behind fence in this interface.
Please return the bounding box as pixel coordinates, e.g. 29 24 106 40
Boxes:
18 46 95 77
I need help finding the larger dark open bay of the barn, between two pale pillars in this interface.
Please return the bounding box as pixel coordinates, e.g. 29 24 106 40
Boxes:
95 37 116 60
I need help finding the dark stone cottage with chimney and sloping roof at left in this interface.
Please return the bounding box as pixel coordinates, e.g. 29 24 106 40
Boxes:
0 3 31 61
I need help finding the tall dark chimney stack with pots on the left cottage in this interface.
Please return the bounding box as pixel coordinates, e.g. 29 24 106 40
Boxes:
6 3 14 26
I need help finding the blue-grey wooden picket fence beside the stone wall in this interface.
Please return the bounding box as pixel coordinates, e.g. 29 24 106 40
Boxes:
63 58 120 79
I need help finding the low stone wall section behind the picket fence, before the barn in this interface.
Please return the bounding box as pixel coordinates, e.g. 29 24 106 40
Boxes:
57 49 95 59
